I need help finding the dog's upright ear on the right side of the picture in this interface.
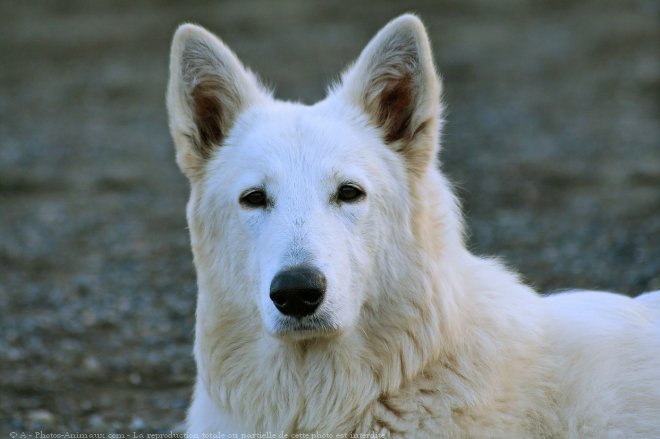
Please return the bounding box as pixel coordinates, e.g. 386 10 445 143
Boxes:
337 14 442 172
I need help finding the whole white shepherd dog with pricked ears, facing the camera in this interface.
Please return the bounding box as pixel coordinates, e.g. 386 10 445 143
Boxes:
167 15 660 438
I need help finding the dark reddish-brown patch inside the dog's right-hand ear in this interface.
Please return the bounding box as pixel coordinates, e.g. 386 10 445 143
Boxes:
377 75 413 143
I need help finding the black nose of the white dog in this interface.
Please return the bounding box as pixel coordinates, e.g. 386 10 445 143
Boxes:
270 266 325 317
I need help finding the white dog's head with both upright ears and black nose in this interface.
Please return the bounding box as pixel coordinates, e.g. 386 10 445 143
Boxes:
167 15 441 340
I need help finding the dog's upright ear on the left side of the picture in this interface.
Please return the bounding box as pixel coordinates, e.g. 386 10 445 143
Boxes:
167 24 268 179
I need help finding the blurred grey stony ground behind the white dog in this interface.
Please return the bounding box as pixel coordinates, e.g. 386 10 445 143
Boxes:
0 0 660 436
